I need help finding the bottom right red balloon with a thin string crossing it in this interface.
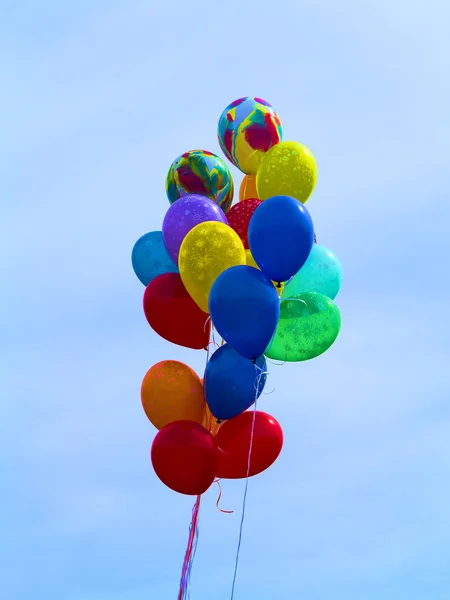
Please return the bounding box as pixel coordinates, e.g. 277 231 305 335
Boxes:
216 410 283 479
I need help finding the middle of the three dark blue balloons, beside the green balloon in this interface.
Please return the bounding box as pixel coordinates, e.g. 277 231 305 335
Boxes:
209 266 280 359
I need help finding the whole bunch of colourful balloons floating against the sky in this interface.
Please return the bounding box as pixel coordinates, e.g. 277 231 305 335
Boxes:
132 98 342 496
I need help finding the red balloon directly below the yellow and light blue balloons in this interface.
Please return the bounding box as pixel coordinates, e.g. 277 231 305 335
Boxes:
144 273 211 350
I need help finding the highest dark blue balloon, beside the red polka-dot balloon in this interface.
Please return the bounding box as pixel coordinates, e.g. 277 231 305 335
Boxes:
248 196 314 282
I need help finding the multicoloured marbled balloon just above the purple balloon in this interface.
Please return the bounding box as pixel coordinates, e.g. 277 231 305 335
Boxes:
166 150 234 213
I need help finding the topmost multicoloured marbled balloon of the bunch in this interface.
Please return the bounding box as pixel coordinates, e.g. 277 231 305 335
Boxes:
217 98 283 173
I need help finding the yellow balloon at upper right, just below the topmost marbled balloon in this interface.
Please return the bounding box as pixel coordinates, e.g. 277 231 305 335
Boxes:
256 142 317 203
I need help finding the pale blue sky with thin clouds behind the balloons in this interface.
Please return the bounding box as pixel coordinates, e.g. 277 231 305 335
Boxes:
0 0 450 600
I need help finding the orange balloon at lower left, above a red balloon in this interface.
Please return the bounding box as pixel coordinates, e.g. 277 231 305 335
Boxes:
141 360 205 429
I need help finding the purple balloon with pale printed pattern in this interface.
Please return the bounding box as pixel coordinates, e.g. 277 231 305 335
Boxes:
162 194 228 265
